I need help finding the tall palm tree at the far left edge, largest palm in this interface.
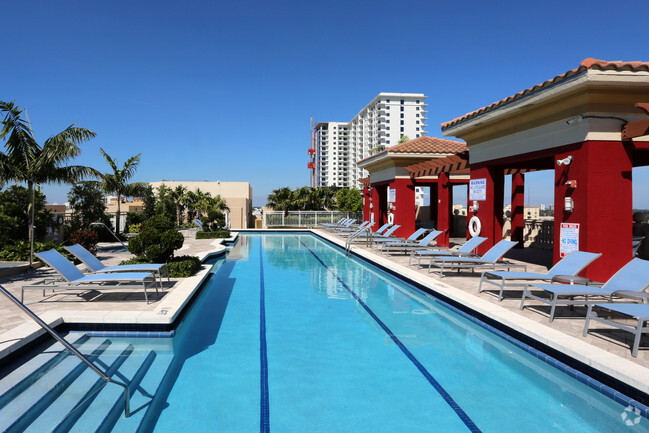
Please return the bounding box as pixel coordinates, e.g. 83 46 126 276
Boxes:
0 101 101 266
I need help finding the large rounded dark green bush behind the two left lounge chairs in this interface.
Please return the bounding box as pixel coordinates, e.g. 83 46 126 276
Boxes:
128 215 184 263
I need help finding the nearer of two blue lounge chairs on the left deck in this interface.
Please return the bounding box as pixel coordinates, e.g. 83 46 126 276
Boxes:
21 250 158 304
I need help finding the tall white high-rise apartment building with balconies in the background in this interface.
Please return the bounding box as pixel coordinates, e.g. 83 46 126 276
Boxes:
309 93 427 188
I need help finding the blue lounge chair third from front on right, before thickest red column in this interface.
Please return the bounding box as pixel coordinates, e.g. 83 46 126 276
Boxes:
478 251 601 301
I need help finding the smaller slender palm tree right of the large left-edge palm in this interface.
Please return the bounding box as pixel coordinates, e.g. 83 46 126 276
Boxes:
99 147 147 236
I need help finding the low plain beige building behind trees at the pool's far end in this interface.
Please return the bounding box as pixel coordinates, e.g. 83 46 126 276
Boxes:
150 180 253 229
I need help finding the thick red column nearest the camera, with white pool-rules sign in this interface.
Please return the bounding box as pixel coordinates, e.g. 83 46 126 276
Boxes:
554 141 633 281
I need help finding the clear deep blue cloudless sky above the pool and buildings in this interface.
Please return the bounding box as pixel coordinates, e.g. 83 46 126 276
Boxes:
0 0 649 207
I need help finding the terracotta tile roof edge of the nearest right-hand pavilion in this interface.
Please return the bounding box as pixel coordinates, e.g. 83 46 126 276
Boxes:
442 58 649 131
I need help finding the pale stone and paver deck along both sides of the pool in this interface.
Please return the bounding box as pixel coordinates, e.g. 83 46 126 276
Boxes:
0 230 649 402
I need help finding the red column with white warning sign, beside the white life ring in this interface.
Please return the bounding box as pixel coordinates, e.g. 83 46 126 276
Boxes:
469 166 505 254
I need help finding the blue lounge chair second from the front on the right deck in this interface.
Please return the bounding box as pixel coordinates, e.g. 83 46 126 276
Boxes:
521 258 649 322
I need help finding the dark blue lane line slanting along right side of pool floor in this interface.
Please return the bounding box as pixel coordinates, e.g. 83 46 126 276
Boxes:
298 239 481 433
